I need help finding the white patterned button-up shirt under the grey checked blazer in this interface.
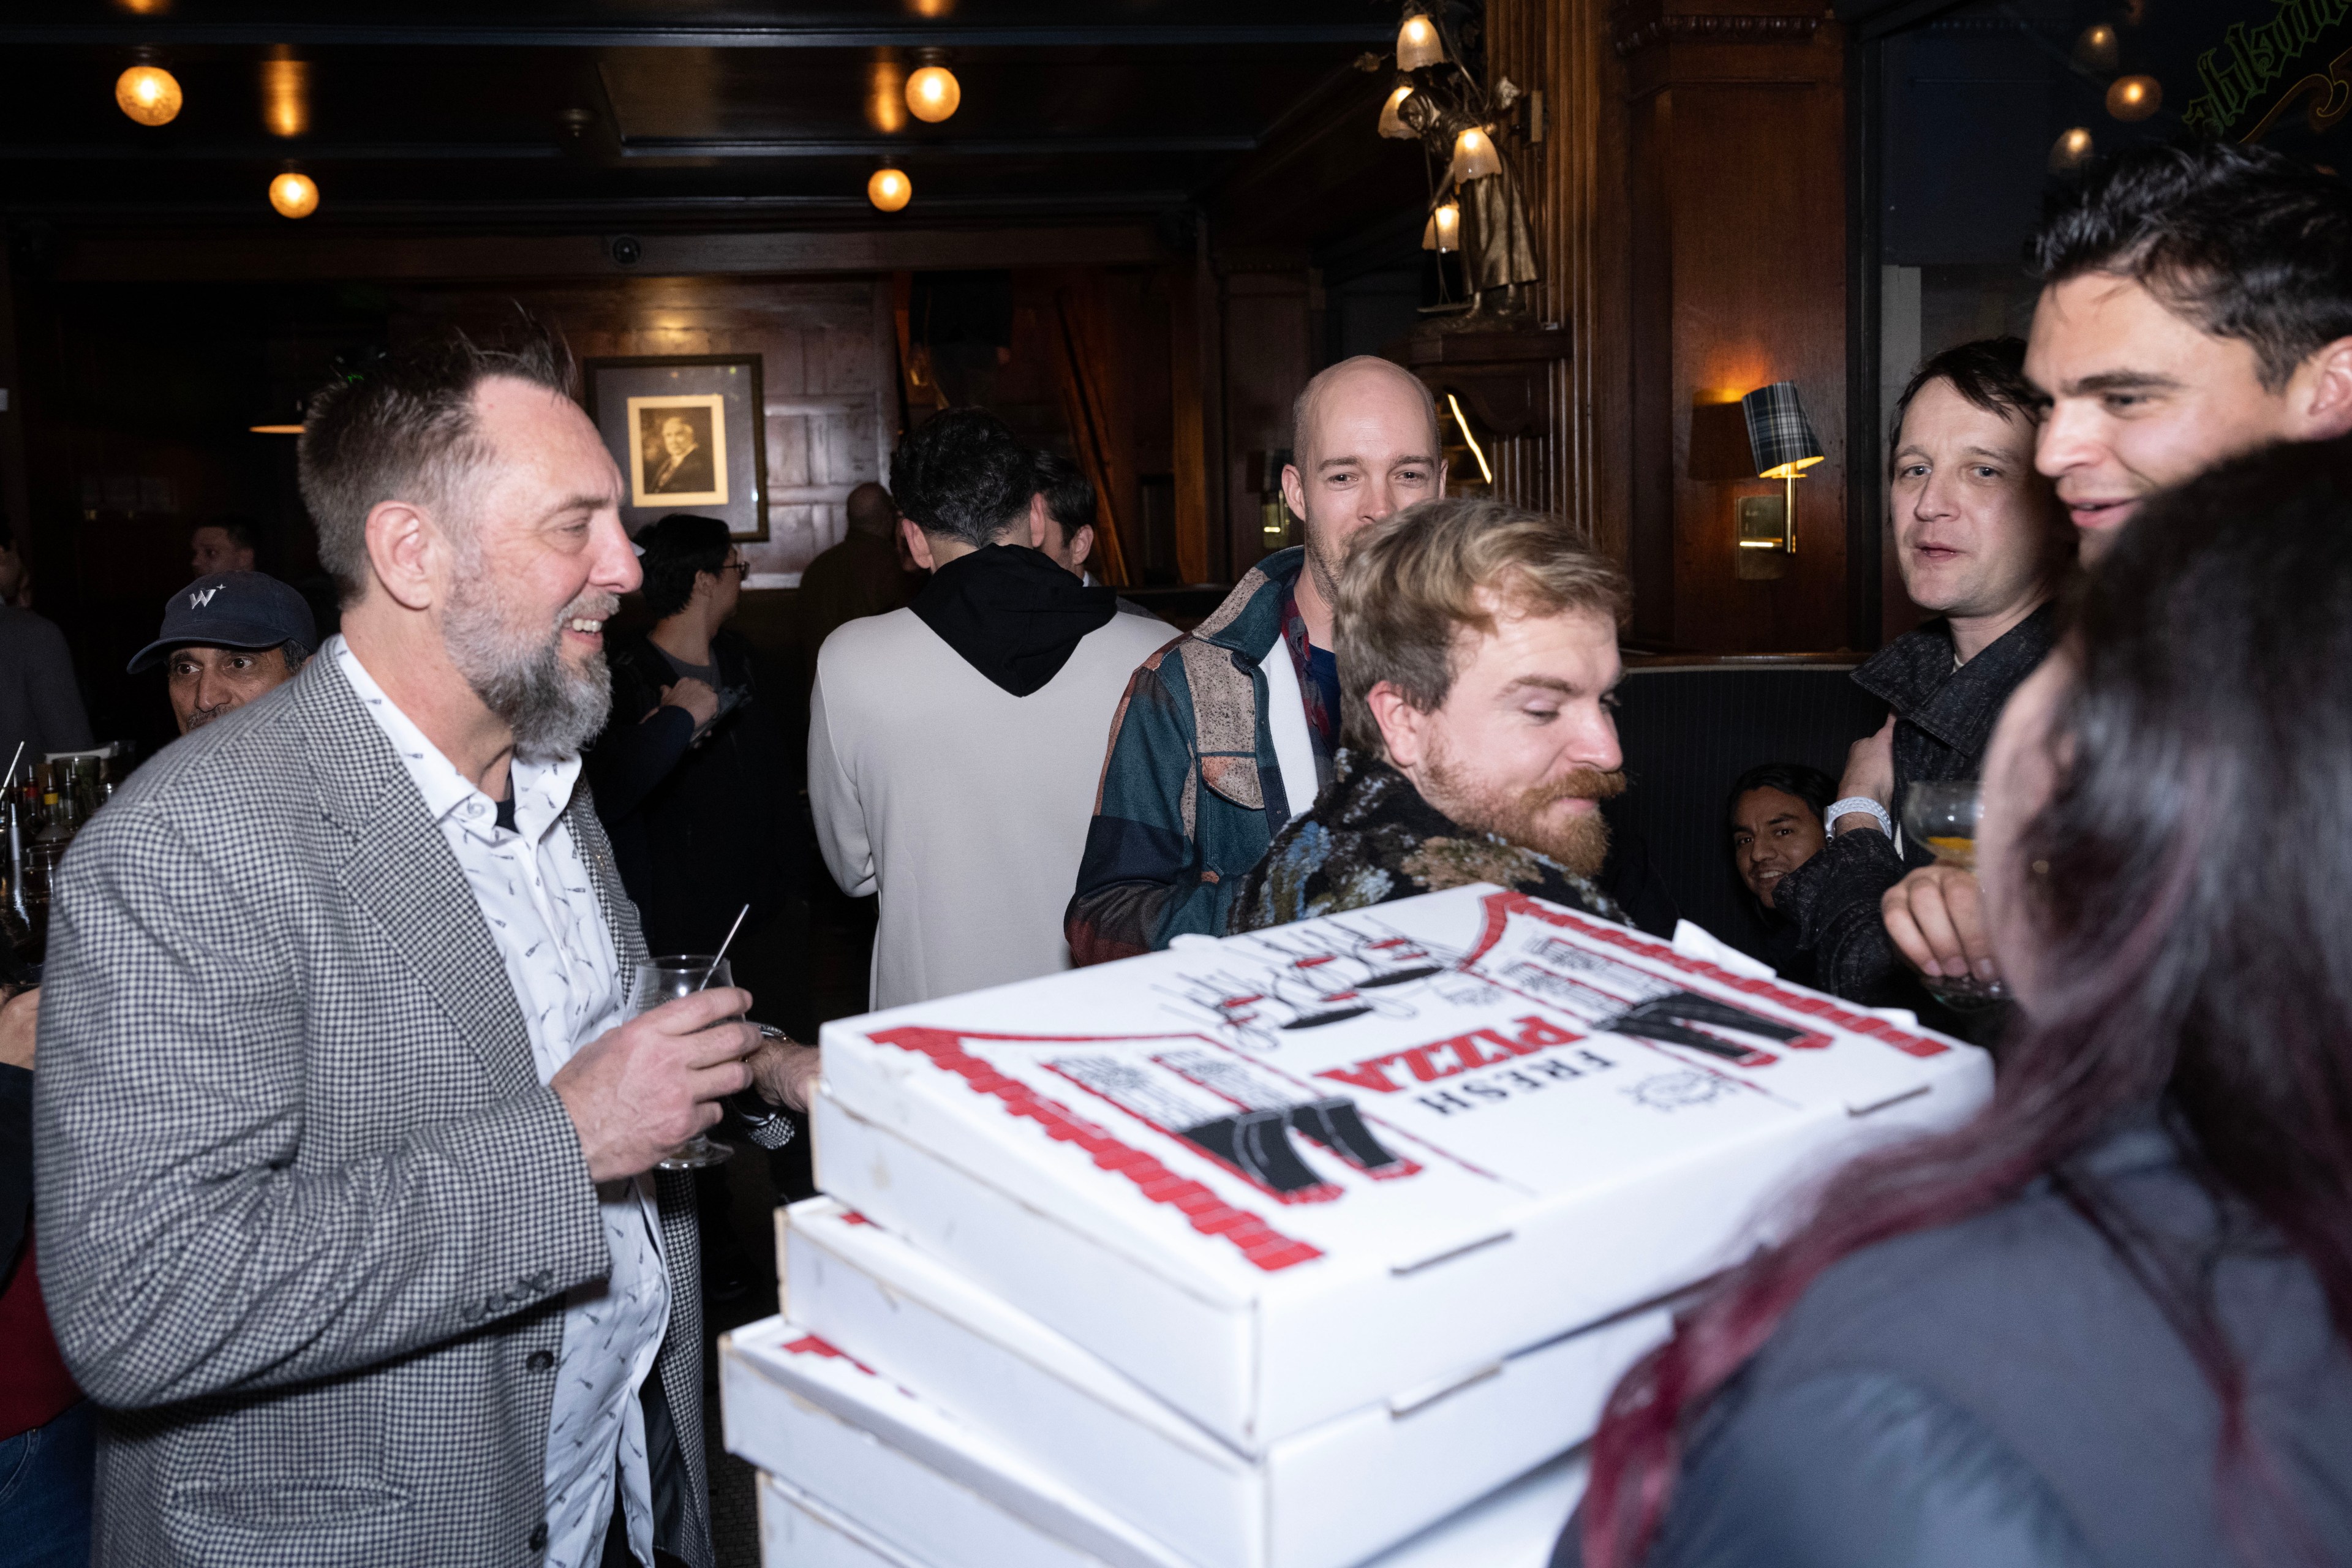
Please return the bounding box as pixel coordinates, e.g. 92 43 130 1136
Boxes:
320 635 670 1568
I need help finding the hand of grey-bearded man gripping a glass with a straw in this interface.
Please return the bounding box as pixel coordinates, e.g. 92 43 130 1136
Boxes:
548 987 760 1183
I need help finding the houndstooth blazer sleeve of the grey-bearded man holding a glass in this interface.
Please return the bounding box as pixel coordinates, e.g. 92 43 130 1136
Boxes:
33 802 611 1408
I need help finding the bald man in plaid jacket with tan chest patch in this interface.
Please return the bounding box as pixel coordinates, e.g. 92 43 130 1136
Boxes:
1063 355 1447 964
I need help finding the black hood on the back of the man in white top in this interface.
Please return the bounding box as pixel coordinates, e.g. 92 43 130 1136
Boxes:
913 545 1120 696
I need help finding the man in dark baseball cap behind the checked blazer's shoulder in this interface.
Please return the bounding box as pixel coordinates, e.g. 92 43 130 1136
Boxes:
129 571 317 736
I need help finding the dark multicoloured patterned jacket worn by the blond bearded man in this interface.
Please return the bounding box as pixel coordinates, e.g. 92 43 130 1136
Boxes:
1227 750 1625 931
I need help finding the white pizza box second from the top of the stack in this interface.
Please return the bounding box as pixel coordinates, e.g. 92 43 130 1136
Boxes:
781 1197 1670 1568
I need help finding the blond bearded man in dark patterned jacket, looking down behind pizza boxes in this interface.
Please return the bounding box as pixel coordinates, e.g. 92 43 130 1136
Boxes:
1230 499 1632 931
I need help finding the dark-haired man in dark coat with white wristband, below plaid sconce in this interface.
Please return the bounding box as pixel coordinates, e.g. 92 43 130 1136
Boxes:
1771 339 2072 1006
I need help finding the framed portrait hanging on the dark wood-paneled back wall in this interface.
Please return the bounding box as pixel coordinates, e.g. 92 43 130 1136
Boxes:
581 355 767 541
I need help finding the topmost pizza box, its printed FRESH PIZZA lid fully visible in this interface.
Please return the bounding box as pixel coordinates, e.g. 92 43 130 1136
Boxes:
814 886 1992 1453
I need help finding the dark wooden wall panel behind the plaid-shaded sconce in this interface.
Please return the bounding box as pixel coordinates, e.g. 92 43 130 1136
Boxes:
1616 0 1849 654
